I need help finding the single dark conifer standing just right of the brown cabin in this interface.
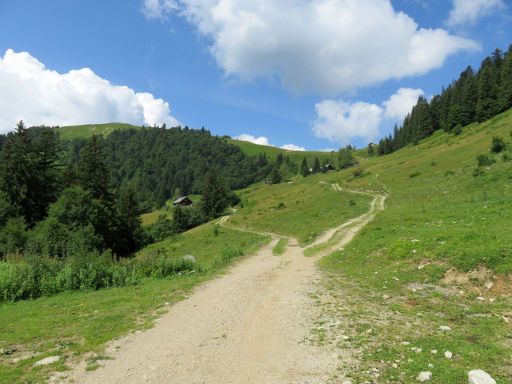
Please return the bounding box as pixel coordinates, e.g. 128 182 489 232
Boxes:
201 170 229 220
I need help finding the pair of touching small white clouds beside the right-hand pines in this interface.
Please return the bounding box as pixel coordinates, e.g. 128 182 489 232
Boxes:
313 88 424 144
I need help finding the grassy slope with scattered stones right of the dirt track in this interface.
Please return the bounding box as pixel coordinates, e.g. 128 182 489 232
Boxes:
314 110 512 383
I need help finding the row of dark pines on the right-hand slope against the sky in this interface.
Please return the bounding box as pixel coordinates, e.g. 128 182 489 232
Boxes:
378 45 512 155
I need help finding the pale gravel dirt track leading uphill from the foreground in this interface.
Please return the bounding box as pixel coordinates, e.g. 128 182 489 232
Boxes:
66 186 385 384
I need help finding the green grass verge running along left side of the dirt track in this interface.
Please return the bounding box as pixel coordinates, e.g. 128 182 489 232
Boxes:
0 223 269 384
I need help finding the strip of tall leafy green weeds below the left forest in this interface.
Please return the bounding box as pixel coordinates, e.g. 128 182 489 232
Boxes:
0 252 202 301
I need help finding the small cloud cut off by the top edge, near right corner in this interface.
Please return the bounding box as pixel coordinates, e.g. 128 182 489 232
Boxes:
447 0 505 26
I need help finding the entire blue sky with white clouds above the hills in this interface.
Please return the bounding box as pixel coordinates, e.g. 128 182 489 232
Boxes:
0 0 512 149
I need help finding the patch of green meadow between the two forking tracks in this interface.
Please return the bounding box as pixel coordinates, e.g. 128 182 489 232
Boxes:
230 173 371 244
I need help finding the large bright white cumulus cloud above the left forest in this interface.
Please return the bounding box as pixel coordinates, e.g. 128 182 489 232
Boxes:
0 49 178 132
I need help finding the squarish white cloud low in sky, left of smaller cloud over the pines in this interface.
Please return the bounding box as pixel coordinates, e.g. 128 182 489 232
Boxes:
313 100 383 144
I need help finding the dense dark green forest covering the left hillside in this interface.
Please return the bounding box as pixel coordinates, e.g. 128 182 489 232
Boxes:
0 122 276 258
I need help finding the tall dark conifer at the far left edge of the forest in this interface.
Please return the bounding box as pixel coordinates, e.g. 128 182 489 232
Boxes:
0 121 59 226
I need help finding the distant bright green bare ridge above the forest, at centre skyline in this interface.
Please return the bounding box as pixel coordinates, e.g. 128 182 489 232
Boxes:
227 139 338 167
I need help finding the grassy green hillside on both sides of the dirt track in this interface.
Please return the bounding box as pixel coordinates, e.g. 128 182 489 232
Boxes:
0 110 512 384
